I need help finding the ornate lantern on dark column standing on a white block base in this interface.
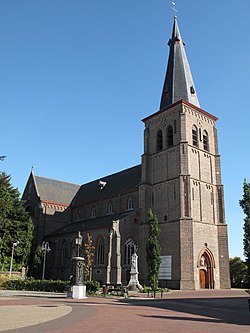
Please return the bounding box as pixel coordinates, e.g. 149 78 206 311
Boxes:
72 231 86 299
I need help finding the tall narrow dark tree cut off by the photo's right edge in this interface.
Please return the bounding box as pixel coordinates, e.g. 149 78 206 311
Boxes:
240 179 250 288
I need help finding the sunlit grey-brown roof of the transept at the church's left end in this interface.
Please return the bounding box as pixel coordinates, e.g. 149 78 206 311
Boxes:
34 176 80 205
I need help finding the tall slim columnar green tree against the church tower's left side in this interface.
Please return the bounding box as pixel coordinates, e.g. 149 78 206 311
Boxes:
146 208 161 296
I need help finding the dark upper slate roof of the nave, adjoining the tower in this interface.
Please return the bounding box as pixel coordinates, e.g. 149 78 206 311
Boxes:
72 165 141 206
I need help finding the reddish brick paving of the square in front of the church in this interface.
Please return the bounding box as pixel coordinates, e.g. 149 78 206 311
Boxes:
0 290 250 333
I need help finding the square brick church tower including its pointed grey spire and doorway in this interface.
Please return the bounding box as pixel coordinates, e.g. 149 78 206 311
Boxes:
139 17 230 289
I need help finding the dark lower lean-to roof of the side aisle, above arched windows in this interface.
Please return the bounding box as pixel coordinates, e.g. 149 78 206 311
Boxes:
49 211 134 237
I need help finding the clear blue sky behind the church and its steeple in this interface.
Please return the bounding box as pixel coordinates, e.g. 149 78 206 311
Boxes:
0 0 250 258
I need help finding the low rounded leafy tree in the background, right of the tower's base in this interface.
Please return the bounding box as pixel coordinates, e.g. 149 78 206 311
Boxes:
229 257 247 287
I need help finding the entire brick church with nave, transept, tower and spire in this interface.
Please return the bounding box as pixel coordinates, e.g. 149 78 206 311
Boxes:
23 17 230 289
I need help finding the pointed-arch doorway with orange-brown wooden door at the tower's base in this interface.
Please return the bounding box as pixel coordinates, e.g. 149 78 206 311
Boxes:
198 248 214 289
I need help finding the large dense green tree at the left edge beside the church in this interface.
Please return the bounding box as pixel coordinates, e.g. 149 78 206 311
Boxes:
0 172 33 270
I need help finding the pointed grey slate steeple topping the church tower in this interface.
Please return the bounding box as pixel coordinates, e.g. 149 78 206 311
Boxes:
160 16 200 110
